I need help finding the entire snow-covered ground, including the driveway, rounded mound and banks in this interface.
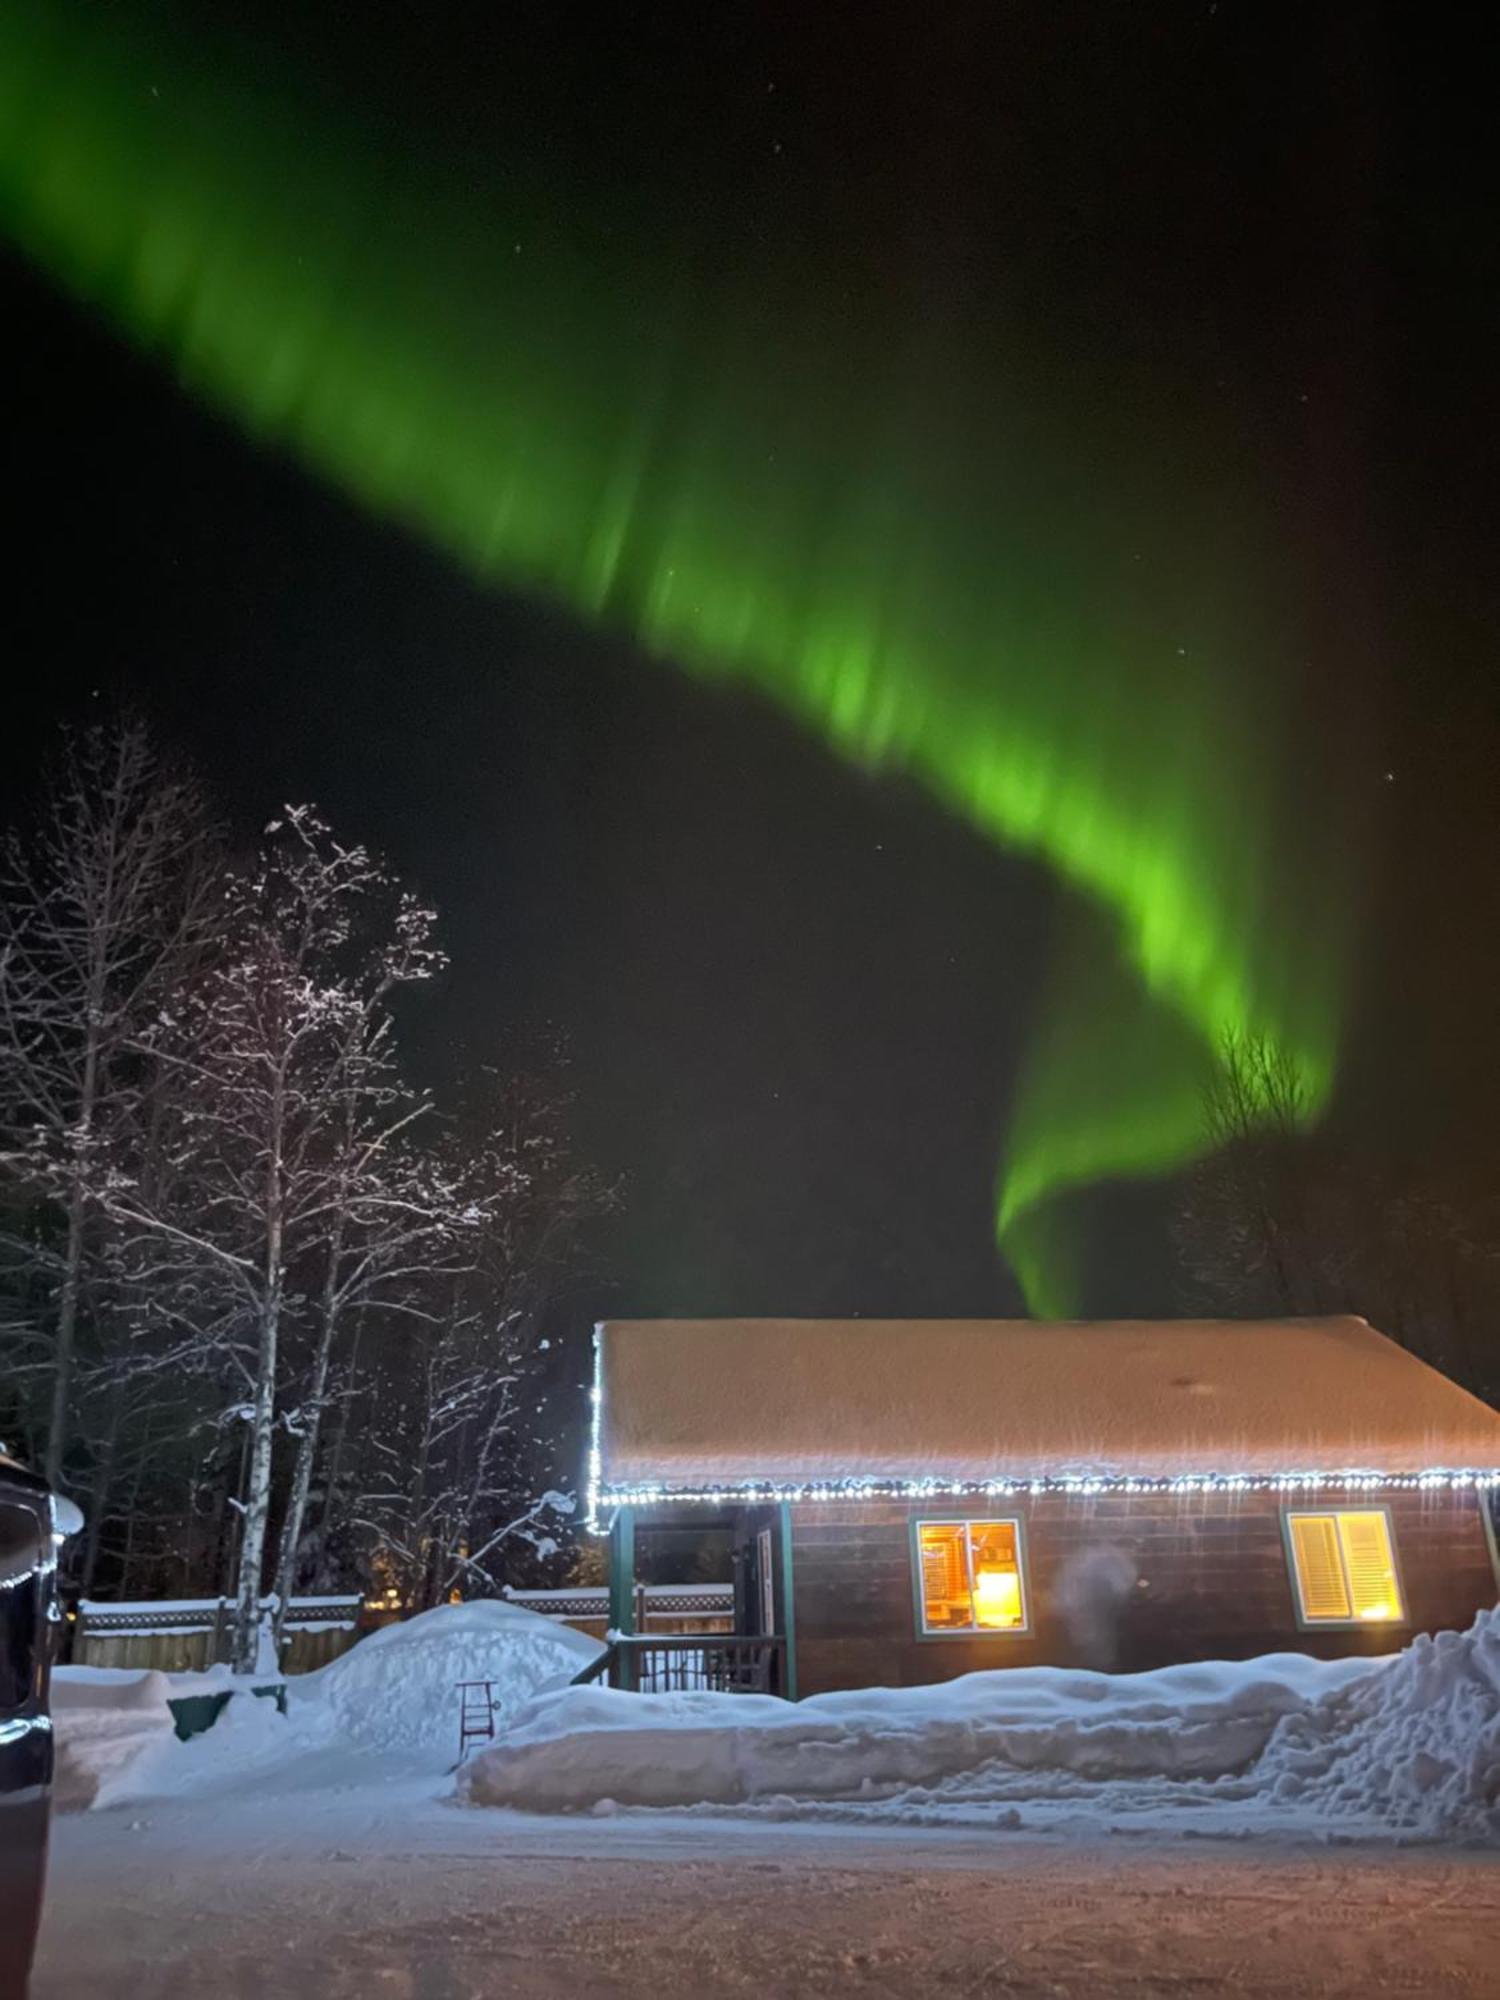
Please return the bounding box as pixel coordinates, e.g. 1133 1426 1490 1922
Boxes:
36 1606 1500 2000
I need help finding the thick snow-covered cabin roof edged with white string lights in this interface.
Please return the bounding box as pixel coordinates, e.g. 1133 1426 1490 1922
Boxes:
594 1318 1500 1500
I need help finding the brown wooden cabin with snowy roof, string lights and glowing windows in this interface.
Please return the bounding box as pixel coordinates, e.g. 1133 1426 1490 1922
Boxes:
590 1318 1500 1698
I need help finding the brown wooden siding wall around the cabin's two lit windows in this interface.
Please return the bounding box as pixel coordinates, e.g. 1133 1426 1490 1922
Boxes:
792 1492 1496 1694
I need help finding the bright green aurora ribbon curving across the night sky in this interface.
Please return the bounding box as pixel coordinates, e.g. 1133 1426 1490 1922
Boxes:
0 6 1350 1314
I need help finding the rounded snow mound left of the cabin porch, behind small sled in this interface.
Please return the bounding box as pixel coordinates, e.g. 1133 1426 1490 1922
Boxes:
286 1598 604 1764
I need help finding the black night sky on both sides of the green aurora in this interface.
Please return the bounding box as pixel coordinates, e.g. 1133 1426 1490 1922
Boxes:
0 0 1500 1314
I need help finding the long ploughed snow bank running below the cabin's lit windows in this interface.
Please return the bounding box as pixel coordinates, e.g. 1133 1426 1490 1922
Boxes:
460 1610 1500 1838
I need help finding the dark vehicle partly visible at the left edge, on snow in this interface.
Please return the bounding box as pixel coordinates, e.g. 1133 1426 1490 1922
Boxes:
0 1458 56 2000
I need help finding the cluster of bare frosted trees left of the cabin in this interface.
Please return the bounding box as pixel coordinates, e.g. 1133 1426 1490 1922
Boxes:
0 720 612 1668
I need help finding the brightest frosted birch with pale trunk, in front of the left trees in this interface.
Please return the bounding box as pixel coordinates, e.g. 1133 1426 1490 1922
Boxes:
108 806 440 1672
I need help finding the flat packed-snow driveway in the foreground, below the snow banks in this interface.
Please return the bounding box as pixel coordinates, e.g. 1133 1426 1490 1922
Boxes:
32 1792 1500 2000
